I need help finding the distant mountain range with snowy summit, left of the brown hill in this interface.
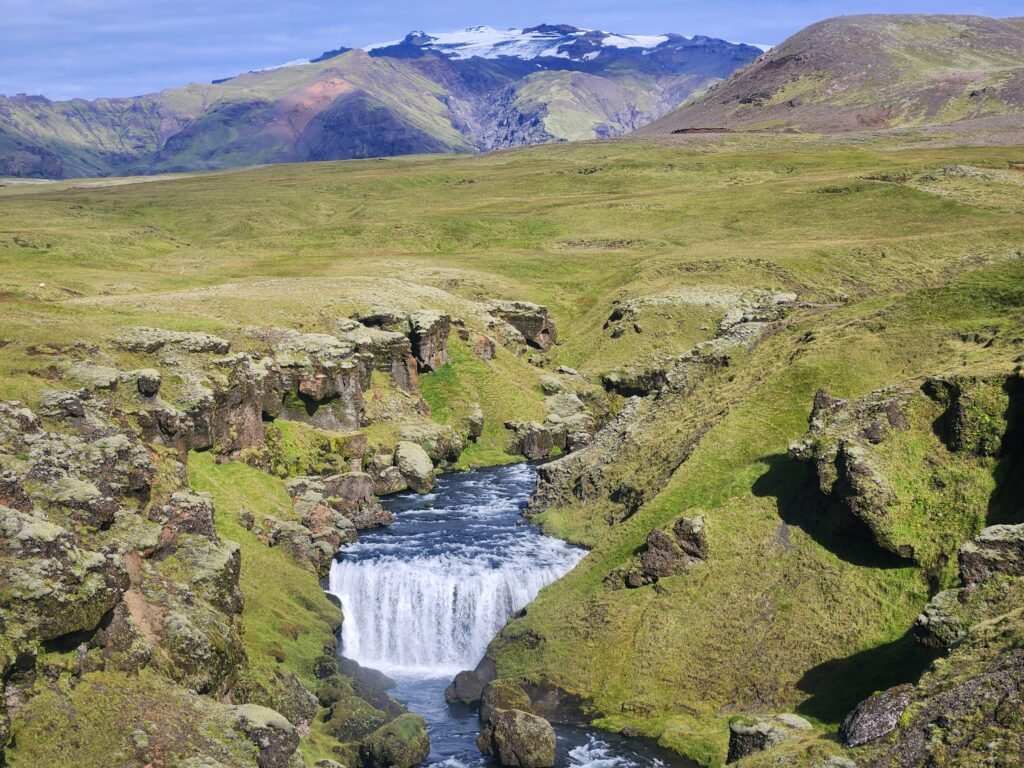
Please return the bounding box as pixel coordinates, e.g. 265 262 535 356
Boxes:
0 25 761 178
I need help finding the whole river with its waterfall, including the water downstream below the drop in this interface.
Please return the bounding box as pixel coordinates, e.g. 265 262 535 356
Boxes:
329 464 685 768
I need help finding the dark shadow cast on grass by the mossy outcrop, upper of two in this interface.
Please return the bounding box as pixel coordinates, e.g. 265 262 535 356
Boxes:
752 454 909 568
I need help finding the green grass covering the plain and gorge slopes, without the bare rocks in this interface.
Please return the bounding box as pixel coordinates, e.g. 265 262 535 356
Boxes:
0 136 1024 764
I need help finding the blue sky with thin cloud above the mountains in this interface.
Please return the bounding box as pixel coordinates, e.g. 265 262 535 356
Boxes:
0 0 1024 99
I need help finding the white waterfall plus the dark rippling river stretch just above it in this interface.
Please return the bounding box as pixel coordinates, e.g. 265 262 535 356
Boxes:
329 466 584 676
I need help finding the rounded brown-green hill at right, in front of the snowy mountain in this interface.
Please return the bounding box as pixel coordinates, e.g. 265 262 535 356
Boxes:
644 15 1024 134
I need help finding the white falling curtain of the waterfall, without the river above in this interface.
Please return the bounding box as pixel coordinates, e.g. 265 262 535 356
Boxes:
330 552 581 675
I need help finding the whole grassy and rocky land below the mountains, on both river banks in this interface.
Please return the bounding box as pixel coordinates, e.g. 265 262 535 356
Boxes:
0 129 1024 768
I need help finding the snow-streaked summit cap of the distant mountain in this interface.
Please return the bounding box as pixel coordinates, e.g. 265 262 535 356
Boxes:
364 24 679 61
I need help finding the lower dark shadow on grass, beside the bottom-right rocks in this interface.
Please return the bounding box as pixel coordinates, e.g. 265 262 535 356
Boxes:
797 631 941 724
